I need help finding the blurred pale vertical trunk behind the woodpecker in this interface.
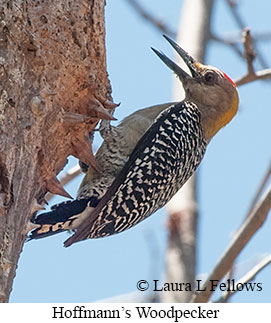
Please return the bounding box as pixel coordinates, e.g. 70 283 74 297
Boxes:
161 0 214 302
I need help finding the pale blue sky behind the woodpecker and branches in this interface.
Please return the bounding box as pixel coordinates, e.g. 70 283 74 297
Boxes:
11 0 271 302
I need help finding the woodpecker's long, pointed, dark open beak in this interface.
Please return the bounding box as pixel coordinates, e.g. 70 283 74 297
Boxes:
152 35 200 81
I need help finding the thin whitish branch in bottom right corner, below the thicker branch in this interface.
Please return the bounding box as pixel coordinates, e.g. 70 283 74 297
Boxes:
215 255 271 303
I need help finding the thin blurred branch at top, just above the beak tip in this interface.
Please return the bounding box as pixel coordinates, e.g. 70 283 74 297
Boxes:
126 0 176 38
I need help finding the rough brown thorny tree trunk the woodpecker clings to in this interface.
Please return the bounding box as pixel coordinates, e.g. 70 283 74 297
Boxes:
0 0 111 302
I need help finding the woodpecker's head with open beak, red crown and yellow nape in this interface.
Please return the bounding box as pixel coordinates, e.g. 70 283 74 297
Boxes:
152 36 239 141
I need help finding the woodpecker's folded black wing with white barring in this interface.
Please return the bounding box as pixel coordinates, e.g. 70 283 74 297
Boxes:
64 102 206 247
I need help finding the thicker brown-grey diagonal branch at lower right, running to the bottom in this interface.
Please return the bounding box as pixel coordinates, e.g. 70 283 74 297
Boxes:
192 186 271 303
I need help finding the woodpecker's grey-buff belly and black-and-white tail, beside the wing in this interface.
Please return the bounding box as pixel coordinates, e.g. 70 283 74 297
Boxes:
28 102 175 240
